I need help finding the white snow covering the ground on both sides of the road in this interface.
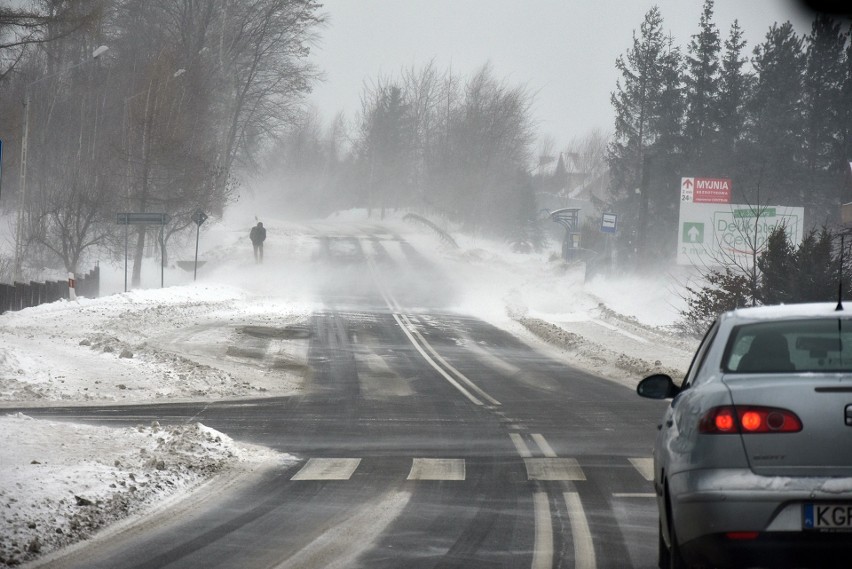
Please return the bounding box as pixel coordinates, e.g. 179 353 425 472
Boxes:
0 197 696 566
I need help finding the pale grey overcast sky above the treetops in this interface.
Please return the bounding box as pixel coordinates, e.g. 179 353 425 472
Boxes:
311 0 812 148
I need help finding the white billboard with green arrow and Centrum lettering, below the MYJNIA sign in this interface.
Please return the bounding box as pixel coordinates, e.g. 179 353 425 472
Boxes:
677 201 805 267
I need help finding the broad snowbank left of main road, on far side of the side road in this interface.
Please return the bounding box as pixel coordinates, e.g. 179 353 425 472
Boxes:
0 285 311 406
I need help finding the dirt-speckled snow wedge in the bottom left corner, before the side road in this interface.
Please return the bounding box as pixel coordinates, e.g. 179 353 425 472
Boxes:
0 413 285 566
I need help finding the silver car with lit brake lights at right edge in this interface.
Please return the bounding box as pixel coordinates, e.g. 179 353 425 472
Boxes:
637 303 852 569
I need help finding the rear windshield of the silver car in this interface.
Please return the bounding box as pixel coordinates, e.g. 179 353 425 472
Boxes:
722 318 852 373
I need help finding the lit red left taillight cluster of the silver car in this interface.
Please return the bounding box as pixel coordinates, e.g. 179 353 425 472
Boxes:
698 405 802 435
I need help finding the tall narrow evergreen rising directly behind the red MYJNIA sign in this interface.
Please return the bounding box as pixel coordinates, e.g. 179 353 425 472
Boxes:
684 0 721 169
